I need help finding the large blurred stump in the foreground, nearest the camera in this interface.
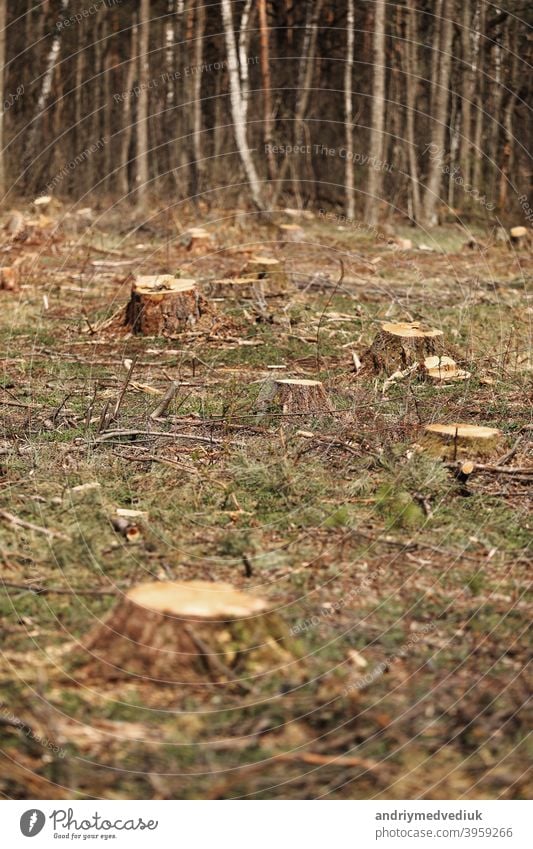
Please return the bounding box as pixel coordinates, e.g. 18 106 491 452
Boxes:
83 581 293 686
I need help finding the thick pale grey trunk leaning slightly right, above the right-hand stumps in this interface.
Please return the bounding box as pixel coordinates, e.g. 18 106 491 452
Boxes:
422 0 453 227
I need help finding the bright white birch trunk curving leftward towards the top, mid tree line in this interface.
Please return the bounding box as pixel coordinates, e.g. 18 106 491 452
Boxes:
221 0 265 211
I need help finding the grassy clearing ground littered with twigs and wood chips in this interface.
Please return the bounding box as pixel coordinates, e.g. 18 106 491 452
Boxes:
0 202 533 799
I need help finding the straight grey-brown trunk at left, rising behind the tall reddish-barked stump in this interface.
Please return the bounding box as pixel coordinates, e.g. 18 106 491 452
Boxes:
136 0 150 215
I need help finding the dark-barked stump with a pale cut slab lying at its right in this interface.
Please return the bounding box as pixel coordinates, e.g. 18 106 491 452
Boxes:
363 321 444 375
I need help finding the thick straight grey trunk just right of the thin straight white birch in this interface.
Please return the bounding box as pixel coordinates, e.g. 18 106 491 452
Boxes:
365 0 385 225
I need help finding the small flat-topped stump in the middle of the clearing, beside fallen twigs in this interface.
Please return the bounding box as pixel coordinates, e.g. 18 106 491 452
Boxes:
257 378 331 415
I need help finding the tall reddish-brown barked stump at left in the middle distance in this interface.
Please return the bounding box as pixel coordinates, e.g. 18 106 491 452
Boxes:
125 274 206 336
